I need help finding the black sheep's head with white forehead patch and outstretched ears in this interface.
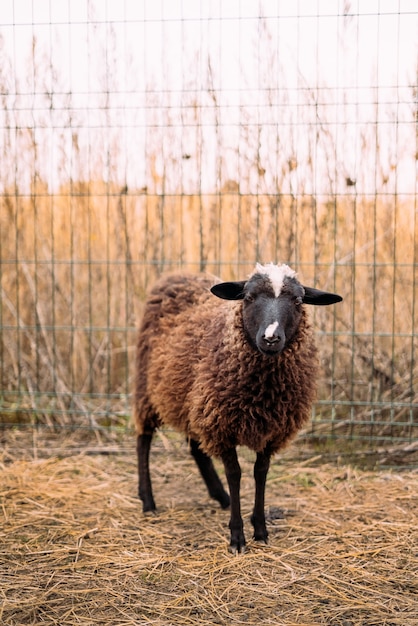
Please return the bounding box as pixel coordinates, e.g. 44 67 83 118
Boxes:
211 263 342 356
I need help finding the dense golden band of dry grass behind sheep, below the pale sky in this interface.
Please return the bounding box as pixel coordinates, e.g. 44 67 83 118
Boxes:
1 182 418 433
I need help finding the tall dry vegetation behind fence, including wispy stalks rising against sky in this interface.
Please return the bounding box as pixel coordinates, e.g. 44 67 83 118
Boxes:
0 9 418 437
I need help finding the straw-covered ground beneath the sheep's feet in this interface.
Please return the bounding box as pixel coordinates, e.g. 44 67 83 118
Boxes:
0 432 418 626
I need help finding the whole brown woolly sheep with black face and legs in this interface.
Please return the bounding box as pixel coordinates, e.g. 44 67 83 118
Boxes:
134 264 342 553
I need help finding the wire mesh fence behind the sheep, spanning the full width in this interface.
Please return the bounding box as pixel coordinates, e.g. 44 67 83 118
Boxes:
0 0 418 447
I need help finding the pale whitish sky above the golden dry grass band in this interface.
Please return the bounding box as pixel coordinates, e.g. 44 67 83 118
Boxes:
0 0 418 193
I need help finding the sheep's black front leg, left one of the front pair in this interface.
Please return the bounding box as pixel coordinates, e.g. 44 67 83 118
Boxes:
222 448 245 554
